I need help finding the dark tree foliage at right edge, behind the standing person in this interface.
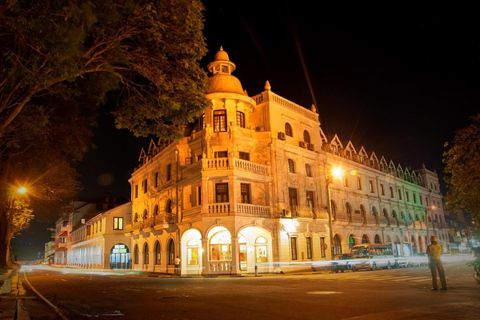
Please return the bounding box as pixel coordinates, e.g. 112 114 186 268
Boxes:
443 114 480 221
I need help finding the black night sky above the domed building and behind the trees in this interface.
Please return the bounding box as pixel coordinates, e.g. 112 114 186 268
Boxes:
12 0 480 262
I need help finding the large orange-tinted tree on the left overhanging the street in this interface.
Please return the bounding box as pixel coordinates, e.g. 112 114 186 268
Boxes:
0 0 208 265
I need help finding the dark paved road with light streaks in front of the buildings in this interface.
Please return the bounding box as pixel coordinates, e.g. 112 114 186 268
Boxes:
17 261 480 320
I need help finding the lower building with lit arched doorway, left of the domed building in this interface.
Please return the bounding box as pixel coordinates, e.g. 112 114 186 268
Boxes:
53 194 131 269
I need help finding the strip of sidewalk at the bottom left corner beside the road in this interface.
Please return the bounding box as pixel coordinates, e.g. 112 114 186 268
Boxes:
0 265 30 320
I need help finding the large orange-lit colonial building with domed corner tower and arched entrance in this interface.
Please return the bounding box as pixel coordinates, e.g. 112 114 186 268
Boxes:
126 49 448 275
